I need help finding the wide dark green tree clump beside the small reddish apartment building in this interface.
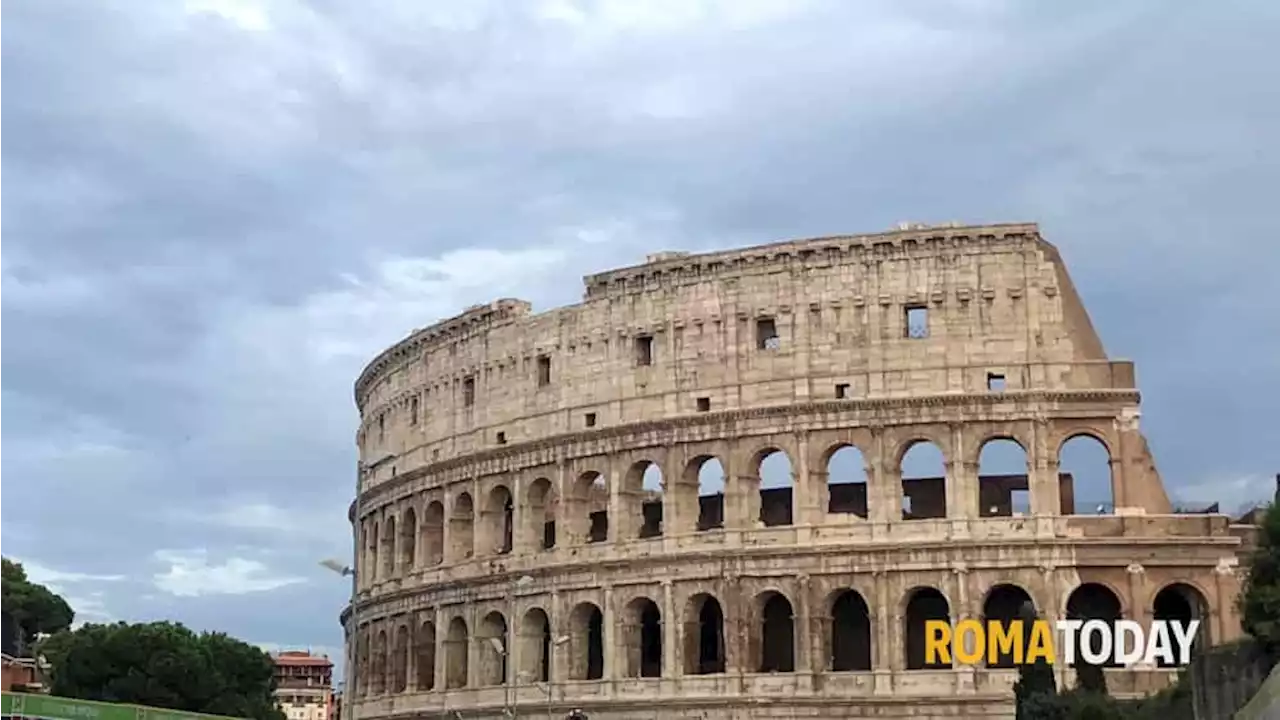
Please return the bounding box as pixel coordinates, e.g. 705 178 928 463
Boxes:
45 623 284 720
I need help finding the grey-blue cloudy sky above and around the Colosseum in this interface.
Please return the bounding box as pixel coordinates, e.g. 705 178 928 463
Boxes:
0 0 1280 676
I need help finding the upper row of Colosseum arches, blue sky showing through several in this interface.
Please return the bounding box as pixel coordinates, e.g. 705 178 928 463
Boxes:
361 436 1111 583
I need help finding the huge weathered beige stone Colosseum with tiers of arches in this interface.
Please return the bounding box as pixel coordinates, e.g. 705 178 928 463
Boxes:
342 224 1247 720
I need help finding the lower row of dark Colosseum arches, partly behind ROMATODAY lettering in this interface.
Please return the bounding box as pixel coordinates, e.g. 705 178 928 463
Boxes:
357 573 1208 696
